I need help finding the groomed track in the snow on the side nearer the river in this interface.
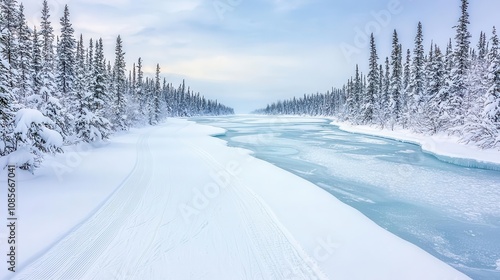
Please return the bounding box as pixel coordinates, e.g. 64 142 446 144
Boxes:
187 144 328 279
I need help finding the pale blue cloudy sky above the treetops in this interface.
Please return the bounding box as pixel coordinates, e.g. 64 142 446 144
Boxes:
21 0 500 113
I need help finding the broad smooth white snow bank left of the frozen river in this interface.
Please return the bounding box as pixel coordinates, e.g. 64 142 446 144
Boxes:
0 119 468 279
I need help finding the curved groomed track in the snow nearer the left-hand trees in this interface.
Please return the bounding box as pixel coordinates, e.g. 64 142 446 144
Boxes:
12 130 156 279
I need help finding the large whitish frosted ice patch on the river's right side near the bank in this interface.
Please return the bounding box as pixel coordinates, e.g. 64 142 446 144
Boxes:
301 143 500 222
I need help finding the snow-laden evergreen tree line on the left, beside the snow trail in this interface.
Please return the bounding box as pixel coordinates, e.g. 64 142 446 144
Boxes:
0 0 234 171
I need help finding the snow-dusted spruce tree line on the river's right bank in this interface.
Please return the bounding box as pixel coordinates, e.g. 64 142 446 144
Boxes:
255 0 500 149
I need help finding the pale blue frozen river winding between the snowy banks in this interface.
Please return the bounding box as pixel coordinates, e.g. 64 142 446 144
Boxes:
194 116 500 279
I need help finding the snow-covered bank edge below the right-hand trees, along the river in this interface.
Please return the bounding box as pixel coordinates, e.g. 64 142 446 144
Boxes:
329 119 500 170
